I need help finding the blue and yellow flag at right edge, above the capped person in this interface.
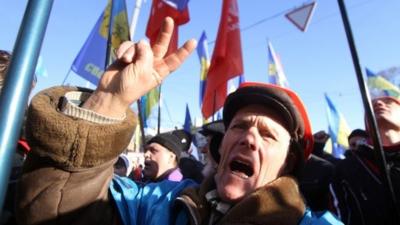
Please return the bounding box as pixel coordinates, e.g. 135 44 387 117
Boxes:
366 69 400 98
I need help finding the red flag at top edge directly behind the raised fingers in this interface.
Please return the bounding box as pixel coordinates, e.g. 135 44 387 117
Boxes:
146 0 190 55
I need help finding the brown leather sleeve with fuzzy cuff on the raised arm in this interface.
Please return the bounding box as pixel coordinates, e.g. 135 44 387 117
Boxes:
16 87 136 224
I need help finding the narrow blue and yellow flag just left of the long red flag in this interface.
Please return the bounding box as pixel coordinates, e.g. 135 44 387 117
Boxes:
197 31 210 107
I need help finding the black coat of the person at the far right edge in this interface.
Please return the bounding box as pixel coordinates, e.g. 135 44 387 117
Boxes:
333 145 400 225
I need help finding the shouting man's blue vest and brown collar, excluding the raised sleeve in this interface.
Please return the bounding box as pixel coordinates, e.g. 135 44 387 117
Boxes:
111 171 342 225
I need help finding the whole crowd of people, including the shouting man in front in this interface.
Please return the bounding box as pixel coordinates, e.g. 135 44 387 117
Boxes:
0 18 400 225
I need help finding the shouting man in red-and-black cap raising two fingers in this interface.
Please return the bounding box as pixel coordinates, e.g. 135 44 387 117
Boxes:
17 18 341 225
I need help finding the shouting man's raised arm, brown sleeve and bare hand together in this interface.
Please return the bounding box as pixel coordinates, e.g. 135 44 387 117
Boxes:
17 18 196 224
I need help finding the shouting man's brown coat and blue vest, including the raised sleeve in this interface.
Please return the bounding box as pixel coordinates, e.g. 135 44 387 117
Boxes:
17 88 340 225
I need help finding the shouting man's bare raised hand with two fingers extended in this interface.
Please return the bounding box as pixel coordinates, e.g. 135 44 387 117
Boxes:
83 17 196 117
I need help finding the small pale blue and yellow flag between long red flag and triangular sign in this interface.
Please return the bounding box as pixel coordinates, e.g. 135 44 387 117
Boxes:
268 41 289 87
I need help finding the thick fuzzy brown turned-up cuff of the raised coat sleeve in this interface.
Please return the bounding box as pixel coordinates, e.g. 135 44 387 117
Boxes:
26 87 137 171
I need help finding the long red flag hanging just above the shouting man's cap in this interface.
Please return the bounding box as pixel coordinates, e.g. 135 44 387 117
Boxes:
201 0 243 118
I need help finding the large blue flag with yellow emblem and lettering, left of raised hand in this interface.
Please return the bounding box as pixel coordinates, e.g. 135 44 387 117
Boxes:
71 0 129 85
